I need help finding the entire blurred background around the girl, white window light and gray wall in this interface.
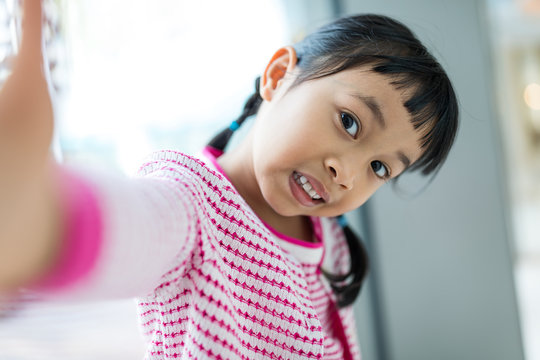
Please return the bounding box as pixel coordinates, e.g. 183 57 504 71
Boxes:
0 0 540 360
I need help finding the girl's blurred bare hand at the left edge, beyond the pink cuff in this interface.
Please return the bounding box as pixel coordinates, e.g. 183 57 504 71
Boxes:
0 0 60 292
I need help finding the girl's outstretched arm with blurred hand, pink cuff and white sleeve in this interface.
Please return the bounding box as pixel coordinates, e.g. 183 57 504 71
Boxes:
0 0 200 300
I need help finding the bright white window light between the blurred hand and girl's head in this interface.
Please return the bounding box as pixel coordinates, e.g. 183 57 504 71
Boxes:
58 0 288 173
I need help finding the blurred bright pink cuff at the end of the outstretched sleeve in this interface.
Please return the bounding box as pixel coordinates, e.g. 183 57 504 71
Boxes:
33 168 103 291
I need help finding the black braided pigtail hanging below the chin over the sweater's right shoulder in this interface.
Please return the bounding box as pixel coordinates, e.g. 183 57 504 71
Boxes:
321 215 368 308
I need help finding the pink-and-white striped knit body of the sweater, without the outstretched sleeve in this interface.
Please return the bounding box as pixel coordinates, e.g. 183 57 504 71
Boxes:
133 151 360 359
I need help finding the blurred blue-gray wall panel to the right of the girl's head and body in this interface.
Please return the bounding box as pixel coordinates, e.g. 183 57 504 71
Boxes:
342 0 524 360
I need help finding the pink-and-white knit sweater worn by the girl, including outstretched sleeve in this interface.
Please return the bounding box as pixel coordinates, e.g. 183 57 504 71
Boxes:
40 151 360 360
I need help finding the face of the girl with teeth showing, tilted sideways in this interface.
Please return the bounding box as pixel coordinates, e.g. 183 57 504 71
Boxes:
251 63 422 216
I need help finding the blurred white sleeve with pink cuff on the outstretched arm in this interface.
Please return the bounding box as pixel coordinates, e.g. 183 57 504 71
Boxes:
38 163 197 300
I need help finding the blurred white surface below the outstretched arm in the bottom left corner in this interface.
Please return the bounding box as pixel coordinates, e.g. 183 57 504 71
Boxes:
0 300 144 360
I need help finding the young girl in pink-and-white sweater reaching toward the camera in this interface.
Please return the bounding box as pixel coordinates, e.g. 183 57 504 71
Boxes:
0 0 457 359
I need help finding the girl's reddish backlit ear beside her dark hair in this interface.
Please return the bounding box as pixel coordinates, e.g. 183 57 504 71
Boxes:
260 46 297 101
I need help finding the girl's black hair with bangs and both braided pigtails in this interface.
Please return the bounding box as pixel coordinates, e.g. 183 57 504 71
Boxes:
209 14 458 307
